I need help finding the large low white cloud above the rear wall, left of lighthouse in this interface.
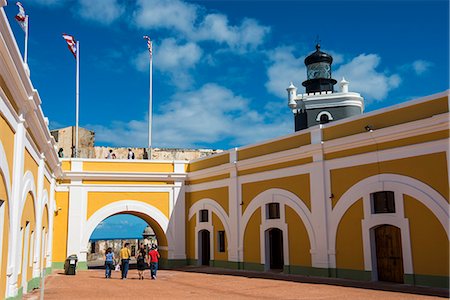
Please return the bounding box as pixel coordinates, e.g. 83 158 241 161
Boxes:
86 83 292 148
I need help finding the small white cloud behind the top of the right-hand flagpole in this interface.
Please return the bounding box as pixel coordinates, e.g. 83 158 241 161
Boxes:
132 38 203 89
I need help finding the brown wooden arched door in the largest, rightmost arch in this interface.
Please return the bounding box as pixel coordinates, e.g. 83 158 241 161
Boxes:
375 225 403 283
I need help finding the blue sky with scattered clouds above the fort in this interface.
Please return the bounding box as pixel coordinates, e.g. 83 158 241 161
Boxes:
5 0 449 149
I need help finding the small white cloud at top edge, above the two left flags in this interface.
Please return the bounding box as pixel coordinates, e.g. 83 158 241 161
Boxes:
78 0 125 25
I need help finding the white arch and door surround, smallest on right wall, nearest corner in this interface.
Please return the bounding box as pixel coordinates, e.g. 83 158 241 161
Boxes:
188 198 231 260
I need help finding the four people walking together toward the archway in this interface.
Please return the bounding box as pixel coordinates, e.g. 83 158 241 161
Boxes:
105 243 160 280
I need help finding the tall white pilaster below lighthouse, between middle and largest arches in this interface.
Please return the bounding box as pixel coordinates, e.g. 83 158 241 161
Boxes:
310 126 331 268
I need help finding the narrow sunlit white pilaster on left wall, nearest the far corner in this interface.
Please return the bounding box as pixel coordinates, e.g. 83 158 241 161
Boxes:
33 154 45 278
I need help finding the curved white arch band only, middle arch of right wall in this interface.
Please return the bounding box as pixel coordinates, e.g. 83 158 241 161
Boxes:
239 188 316 252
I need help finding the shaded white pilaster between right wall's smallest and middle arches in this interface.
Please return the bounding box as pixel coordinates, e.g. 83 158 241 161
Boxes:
226 148 243 262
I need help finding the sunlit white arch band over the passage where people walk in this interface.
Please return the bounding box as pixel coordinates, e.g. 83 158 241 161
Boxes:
81 200 169 248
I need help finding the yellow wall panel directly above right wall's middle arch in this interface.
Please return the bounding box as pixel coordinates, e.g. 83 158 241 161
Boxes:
242 174 311 212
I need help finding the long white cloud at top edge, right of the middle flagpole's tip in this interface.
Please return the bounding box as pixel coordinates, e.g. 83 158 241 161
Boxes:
134 0 270 53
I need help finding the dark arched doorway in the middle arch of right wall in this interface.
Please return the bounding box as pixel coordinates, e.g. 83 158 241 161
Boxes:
265 228 284 270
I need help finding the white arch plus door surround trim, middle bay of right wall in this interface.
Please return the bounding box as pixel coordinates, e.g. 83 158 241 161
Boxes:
239 188 316 264
